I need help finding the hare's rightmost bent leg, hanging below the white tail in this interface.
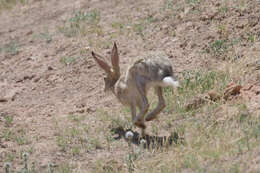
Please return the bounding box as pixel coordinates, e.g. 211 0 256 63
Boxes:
145 86 165 121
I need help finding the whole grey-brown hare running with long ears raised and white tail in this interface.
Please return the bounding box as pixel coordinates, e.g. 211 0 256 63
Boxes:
92 43 179 135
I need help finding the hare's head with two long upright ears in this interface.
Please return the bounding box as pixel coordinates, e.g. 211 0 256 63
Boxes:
92 43 120 91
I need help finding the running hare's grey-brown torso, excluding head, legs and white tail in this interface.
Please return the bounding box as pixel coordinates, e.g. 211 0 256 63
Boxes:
114 52 173 105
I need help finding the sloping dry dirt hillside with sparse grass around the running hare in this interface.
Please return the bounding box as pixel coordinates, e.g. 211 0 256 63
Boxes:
0 0 260 173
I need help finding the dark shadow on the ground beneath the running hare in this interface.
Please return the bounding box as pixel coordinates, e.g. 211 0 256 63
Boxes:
111 127 184 148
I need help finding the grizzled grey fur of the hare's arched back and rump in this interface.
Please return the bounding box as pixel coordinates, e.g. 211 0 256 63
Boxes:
130 52 173 81
